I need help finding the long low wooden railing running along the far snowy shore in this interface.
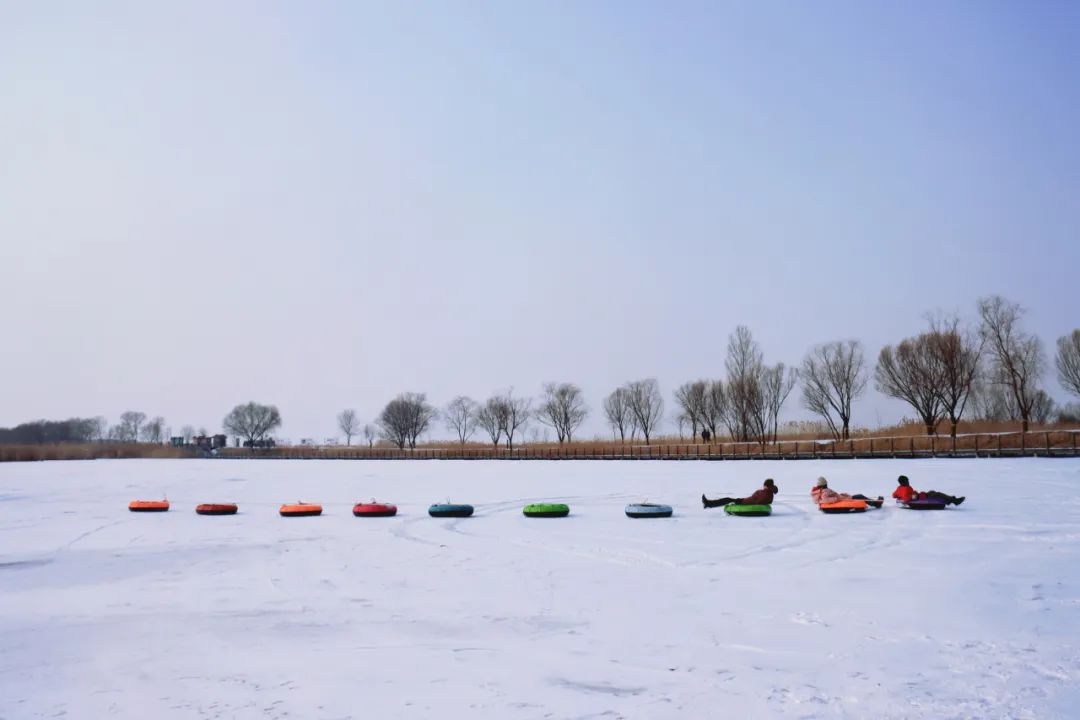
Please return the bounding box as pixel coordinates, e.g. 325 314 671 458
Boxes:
217 430 1080 460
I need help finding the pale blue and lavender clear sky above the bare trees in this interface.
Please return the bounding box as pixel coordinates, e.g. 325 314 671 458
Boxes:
0 0 1080 438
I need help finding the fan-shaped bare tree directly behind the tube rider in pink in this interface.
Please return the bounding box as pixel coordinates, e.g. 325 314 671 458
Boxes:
801 340 867 439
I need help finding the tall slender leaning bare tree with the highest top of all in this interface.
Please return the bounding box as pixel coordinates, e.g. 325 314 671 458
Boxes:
978 295 1047 433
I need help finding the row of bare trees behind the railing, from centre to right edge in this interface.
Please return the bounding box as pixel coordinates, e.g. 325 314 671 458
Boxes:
347 296 1080 448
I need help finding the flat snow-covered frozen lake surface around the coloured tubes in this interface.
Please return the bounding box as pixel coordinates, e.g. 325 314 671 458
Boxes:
0 459 1080 720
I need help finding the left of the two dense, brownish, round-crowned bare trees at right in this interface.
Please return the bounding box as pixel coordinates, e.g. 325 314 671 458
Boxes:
874 332 942 435
